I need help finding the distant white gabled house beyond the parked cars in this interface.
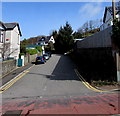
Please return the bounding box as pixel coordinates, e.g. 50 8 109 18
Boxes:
36 36 55 54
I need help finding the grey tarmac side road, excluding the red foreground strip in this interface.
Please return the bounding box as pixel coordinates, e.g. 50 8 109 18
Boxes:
2 54 117 114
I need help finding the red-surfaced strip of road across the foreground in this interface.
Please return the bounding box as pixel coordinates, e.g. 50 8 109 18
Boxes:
2 94 120 116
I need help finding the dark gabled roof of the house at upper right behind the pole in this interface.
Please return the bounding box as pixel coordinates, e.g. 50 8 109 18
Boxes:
103 6 120 23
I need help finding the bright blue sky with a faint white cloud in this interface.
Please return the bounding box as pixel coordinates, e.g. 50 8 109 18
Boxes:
1 2 111 40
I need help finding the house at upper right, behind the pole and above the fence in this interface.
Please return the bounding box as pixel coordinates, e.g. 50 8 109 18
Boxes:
100 6 120 31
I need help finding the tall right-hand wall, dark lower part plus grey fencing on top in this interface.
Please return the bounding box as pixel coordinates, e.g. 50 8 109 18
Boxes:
74 27 117 81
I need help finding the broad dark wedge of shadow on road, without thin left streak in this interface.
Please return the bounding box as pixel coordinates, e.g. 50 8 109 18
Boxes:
50 54 80 81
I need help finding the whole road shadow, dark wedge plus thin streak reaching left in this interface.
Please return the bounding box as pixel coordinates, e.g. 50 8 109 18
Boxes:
28 54 80 81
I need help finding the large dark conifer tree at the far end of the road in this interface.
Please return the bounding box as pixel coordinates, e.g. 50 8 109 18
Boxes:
55 22 73 53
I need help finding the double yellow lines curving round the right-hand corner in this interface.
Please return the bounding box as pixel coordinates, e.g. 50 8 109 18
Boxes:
75 69 114 93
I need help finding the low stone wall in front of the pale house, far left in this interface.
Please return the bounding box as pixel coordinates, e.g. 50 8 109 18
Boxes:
0 60 16 76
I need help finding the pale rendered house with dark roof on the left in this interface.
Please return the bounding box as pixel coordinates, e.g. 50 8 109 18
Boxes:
1 23 22 59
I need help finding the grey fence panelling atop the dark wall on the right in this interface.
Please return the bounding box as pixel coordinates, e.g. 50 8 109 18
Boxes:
77 27 112 48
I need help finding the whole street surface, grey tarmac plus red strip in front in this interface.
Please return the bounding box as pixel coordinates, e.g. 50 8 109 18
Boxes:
2 54 119 114
